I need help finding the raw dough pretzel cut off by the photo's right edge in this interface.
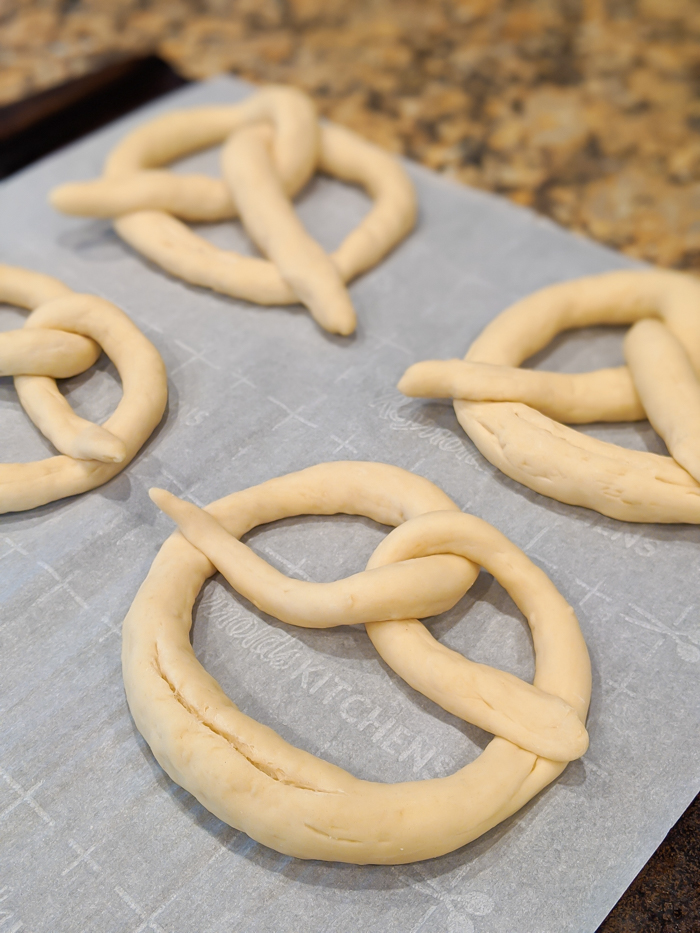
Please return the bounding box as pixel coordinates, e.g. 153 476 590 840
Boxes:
398 271 700 523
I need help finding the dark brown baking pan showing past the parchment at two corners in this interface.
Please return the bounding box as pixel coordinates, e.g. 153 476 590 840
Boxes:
0 55 700 933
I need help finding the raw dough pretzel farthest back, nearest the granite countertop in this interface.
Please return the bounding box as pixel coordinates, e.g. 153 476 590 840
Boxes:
50 86 416 334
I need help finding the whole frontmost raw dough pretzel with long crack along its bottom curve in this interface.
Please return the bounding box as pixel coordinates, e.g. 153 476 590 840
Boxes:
122 462 591 864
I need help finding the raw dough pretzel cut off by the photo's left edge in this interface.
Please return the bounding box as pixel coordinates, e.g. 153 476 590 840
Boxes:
0 265 167 513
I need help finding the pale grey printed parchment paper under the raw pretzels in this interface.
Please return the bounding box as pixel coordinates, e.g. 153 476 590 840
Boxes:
0 78 700 933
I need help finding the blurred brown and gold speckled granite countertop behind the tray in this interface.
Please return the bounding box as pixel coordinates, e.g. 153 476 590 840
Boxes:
0 0 700 273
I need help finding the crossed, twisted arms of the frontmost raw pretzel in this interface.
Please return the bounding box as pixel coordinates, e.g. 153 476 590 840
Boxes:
150 476 588 761
